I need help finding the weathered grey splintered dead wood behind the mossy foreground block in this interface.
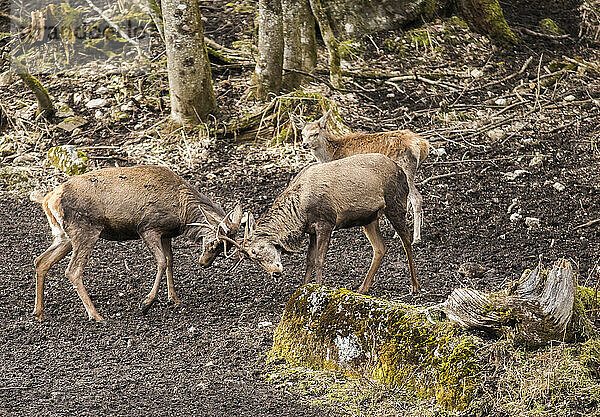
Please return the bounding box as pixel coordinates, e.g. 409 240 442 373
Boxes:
437 259 579 346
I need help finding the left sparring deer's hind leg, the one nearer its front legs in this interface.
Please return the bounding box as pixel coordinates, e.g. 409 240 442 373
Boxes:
65 230 104 322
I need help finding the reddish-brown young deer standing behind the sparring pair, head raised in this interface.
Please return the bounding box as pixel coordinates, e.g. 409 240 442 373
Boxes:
302 110 430 244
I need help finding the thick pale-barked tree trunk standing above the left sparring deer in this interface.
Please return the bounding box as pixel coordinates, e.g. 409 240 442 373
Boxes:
162 0 217 124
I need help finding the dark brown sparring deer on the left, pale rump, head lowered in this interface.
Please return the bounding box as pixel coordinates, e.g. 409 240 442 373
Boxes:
31 166 242 321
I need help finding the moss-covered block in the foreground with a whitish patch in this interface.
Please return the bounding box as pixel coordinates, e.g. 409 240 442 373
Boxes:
270 284 479 410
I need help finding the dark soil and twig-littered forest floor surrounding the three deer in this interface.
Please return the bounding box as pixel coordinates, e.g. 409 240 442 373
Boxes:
0 0 600 416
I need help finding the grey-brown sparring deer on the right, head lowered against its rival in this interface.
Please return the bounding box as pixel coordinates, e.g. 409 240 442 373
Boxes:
243 154 419 294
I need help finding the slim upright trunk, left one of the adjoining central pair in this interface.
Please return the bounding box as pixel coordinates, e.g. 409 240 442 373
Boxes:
254 0 283 100
